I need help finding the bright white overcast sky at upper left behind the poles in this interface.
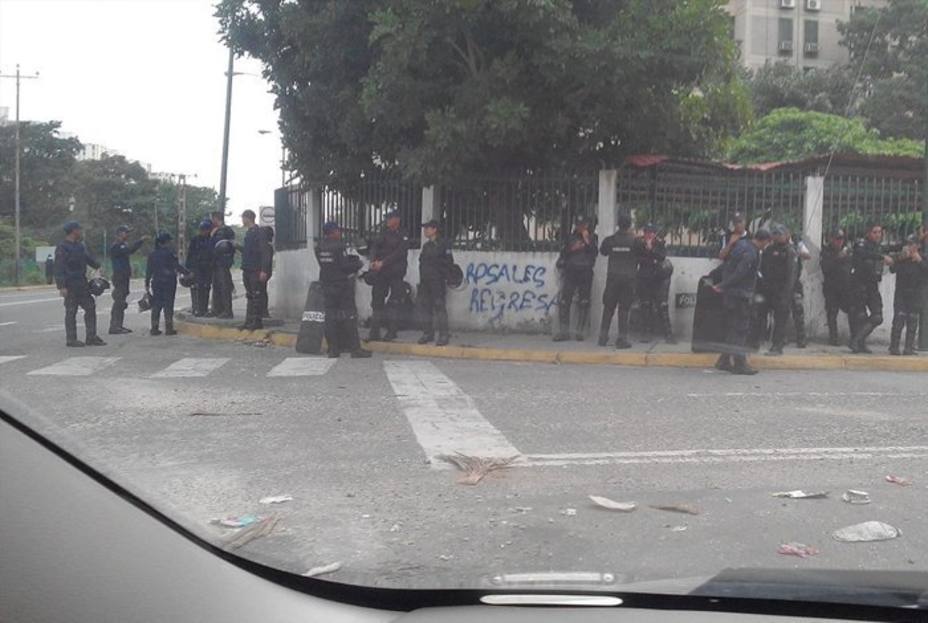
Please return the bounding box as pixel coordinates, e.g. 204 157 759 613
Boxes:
0 0 280 222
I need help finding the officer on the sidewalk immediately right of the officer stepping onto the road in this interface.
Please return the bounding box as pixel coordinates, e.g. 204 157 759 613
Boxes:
752 225 799 355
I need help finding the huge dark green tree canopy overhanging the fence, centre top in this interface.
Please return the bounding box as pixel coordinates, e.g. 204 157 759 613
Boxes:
217 0 749 187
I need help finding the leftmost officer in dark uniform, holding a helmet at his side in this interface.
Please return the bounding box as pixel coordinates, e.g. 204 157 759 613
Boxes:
55 221 106 346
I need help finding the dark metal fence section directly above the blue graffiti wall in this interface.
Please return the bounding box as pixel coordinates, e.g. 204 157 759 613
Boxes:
435 174 599 251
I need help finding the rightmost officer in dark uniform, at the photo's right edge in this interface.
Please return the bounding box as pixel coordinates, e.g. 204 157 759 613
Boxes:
889 235 928 355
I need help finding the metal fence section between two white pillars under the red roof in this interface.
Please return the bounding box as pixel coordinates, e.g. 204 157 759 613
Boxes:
616 167 804 257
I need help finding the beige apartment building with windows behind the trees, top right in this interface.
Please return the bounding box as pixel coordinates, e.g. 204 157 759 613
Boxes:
727 0 887 69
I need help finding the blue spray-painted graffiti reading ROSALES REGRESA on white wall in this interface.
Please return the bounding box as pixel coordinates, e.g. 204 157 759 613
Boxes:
464 262 557 323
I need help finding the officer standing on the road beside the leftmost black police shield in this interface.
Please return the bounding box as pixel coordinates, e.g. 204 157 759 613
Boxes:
316 221 371 359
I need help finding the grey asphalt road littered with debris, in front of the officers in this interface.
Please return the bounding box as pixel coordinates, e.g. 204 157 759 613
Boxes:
0 288 928 587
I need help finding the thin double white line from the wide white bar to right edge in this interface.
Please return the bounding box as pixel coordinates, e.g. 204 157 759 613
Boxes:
521 446 928 467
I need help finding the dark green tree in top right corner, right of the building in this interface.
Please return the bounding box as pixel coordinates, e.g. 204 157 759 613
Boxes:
838 0 928 139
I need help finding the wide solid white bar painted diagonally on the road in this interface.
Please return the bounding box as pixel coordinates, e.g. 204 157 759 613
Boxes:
384 361 520 468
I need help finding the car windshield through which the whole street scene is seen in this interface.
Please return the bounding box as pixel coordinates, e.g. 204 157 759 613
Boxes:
0 0 928 616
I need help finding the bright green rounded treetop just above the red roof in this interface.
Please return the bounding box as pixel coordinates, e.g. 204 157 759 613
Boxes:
728 108 924 163
